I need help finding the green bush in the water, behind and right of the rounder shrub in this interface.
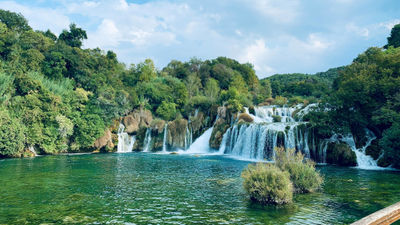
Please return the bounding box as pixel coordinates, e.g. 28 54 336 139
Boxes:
275 148 323 193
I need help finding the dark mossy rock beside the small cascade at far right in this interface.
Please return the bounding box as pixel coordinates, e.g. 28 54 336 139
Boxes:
326 142 357 166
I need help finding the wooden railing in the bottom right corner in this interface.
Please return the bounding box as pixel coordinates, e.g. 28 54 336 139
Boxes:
352 202 400 225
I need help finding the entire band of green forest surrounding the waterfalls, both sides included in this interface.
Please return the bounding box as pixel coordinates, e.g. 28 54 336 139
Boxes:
0 10 400 167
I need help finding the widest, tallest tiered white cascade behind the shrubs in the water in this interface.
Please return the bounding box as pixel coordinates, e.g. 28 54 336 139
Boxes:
219 105 310 160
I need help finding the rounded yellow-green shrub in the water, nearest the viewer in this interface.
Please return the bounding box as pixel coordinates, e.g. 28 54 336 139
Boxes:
242 163 293 204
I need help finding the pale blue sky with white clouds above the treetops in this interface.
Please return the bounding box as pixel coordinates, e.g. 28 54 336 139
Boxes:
0 0 400 78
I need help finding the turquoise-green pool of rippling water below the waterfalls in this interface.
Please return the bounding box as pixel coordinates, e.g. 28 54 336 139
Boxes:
0 153 400 224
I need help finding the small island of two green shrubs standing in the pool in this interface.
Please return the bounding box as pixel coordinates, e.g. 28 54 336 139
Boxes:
242 148 323 204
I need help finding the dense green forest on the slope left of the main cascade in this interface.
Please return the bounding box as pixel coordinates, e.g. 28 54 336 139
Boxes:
0 10 271 157
